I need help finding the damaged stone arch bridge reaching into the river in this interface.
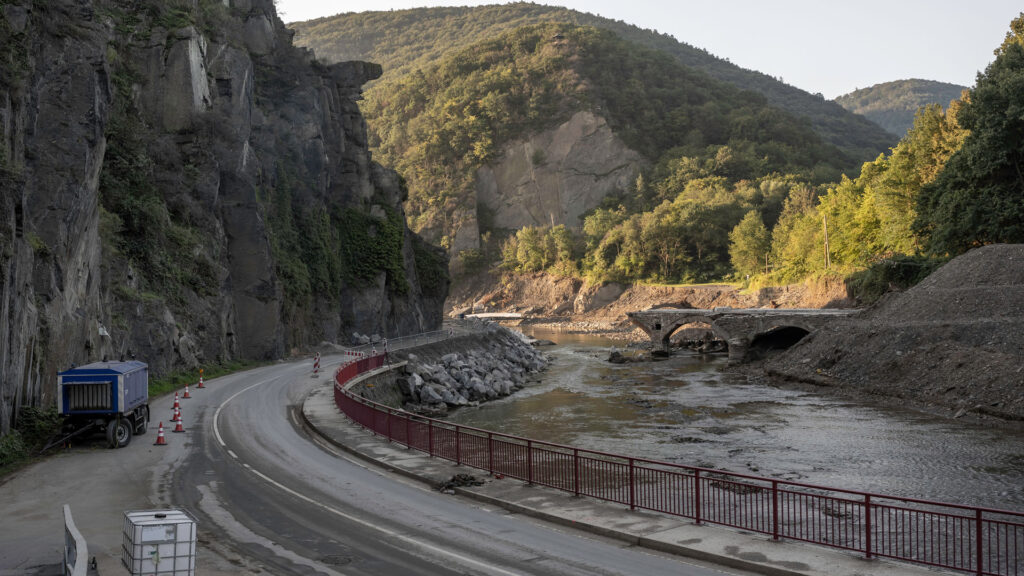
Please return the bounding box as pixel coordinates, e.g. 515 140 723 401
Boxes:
627 307 860 364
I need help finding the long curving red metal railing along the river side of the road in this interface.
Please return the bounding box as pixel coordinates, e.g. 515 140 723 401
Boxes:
334 355 1024 576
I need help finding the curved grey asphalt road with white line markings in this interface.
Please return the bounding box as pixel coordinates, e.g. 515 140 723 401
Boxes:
167 358 743 576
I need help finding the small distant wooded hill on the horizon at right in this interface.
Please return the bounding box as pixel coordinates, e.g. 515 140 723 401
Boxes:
836 78 967 136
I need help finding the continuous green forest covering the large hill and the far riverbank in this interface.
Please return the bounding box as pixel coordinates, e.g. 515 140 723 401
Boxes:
288 4 1024 296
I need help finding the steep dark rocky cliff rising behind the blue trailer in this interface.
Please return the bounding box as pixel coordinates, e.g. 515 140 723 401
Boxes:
0 0 447 433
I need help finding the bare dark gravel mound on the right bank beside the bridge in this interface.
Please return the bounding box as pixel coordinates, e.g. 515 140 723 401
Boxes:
765 244 1024 420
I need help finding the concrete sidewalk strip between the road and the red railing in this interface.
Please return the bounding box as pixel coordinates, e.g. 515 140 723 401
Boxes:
302 387 950 576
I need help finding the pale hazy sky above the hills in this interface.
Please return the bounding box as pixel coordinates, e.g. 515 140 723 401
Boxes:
276 0 1024 98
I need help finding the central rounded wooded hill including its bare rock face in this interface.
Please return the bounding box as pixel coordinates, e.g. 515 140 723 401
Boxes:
350 24 849 280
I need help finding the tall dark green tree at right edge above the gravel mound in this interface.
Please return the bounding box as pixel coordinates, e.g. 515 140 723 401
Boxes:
914 13 1024 254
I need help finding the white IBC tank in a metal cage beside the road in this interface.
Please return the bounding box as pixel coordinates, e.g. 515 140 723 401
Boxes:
121 509 196 576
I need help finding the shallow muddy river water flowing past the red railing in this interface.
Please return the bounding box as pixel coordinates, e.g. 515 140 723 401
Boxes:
450 331 1024 510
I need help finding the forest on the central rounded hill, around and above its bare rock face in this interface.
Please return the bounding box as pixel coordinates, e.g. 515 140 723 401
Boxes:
364 24 846 278
